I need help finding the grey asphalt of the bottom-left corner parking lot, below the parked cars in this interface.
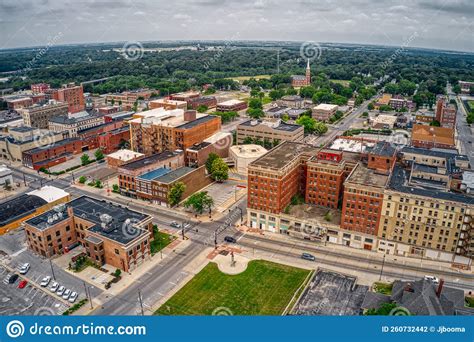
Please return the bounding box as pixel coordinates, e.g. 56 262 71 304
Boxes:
0 266 68 316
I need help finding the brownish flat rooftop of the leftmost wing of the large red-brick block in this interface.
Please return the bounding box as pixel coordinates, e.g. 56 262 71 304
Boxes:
249 141 319 170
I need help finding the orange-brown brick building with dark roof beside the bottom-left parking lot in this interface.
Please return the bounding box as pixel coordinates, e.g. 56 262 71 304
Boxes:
24 196 153 272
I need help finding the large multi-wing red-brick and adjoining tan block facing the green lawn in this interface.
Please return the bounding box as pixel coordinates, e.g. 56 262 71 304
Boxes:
247 142 474 264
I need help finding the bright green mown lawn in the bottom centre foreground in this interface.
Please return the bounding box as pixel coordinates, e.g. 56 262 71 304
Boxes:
155 260 310 315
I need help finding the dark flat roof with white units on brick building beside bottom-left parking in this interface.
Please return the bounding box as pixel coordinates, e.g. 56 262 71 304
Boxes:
27 196 150 244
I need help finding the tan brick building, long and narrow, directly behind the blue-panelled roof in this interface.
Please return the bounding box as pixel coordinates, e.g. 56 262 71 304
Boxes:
117 151 184 198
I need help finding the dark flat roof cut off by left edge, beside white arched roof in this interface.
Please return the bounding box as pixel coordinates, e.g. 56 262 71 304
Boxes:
0 194 48 227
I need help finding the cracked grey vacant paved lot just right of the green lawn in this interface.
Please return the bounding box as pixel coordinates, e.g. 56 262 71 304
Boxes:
292 270 369 316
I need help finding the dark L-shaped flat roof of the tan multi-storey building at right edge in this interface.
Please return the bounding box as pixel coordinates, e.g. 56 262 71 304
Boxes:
388 165 474 204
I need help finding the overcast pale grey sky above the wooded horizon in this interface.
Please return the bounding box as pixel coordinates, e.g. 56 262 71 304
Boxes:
0 0 474 52
